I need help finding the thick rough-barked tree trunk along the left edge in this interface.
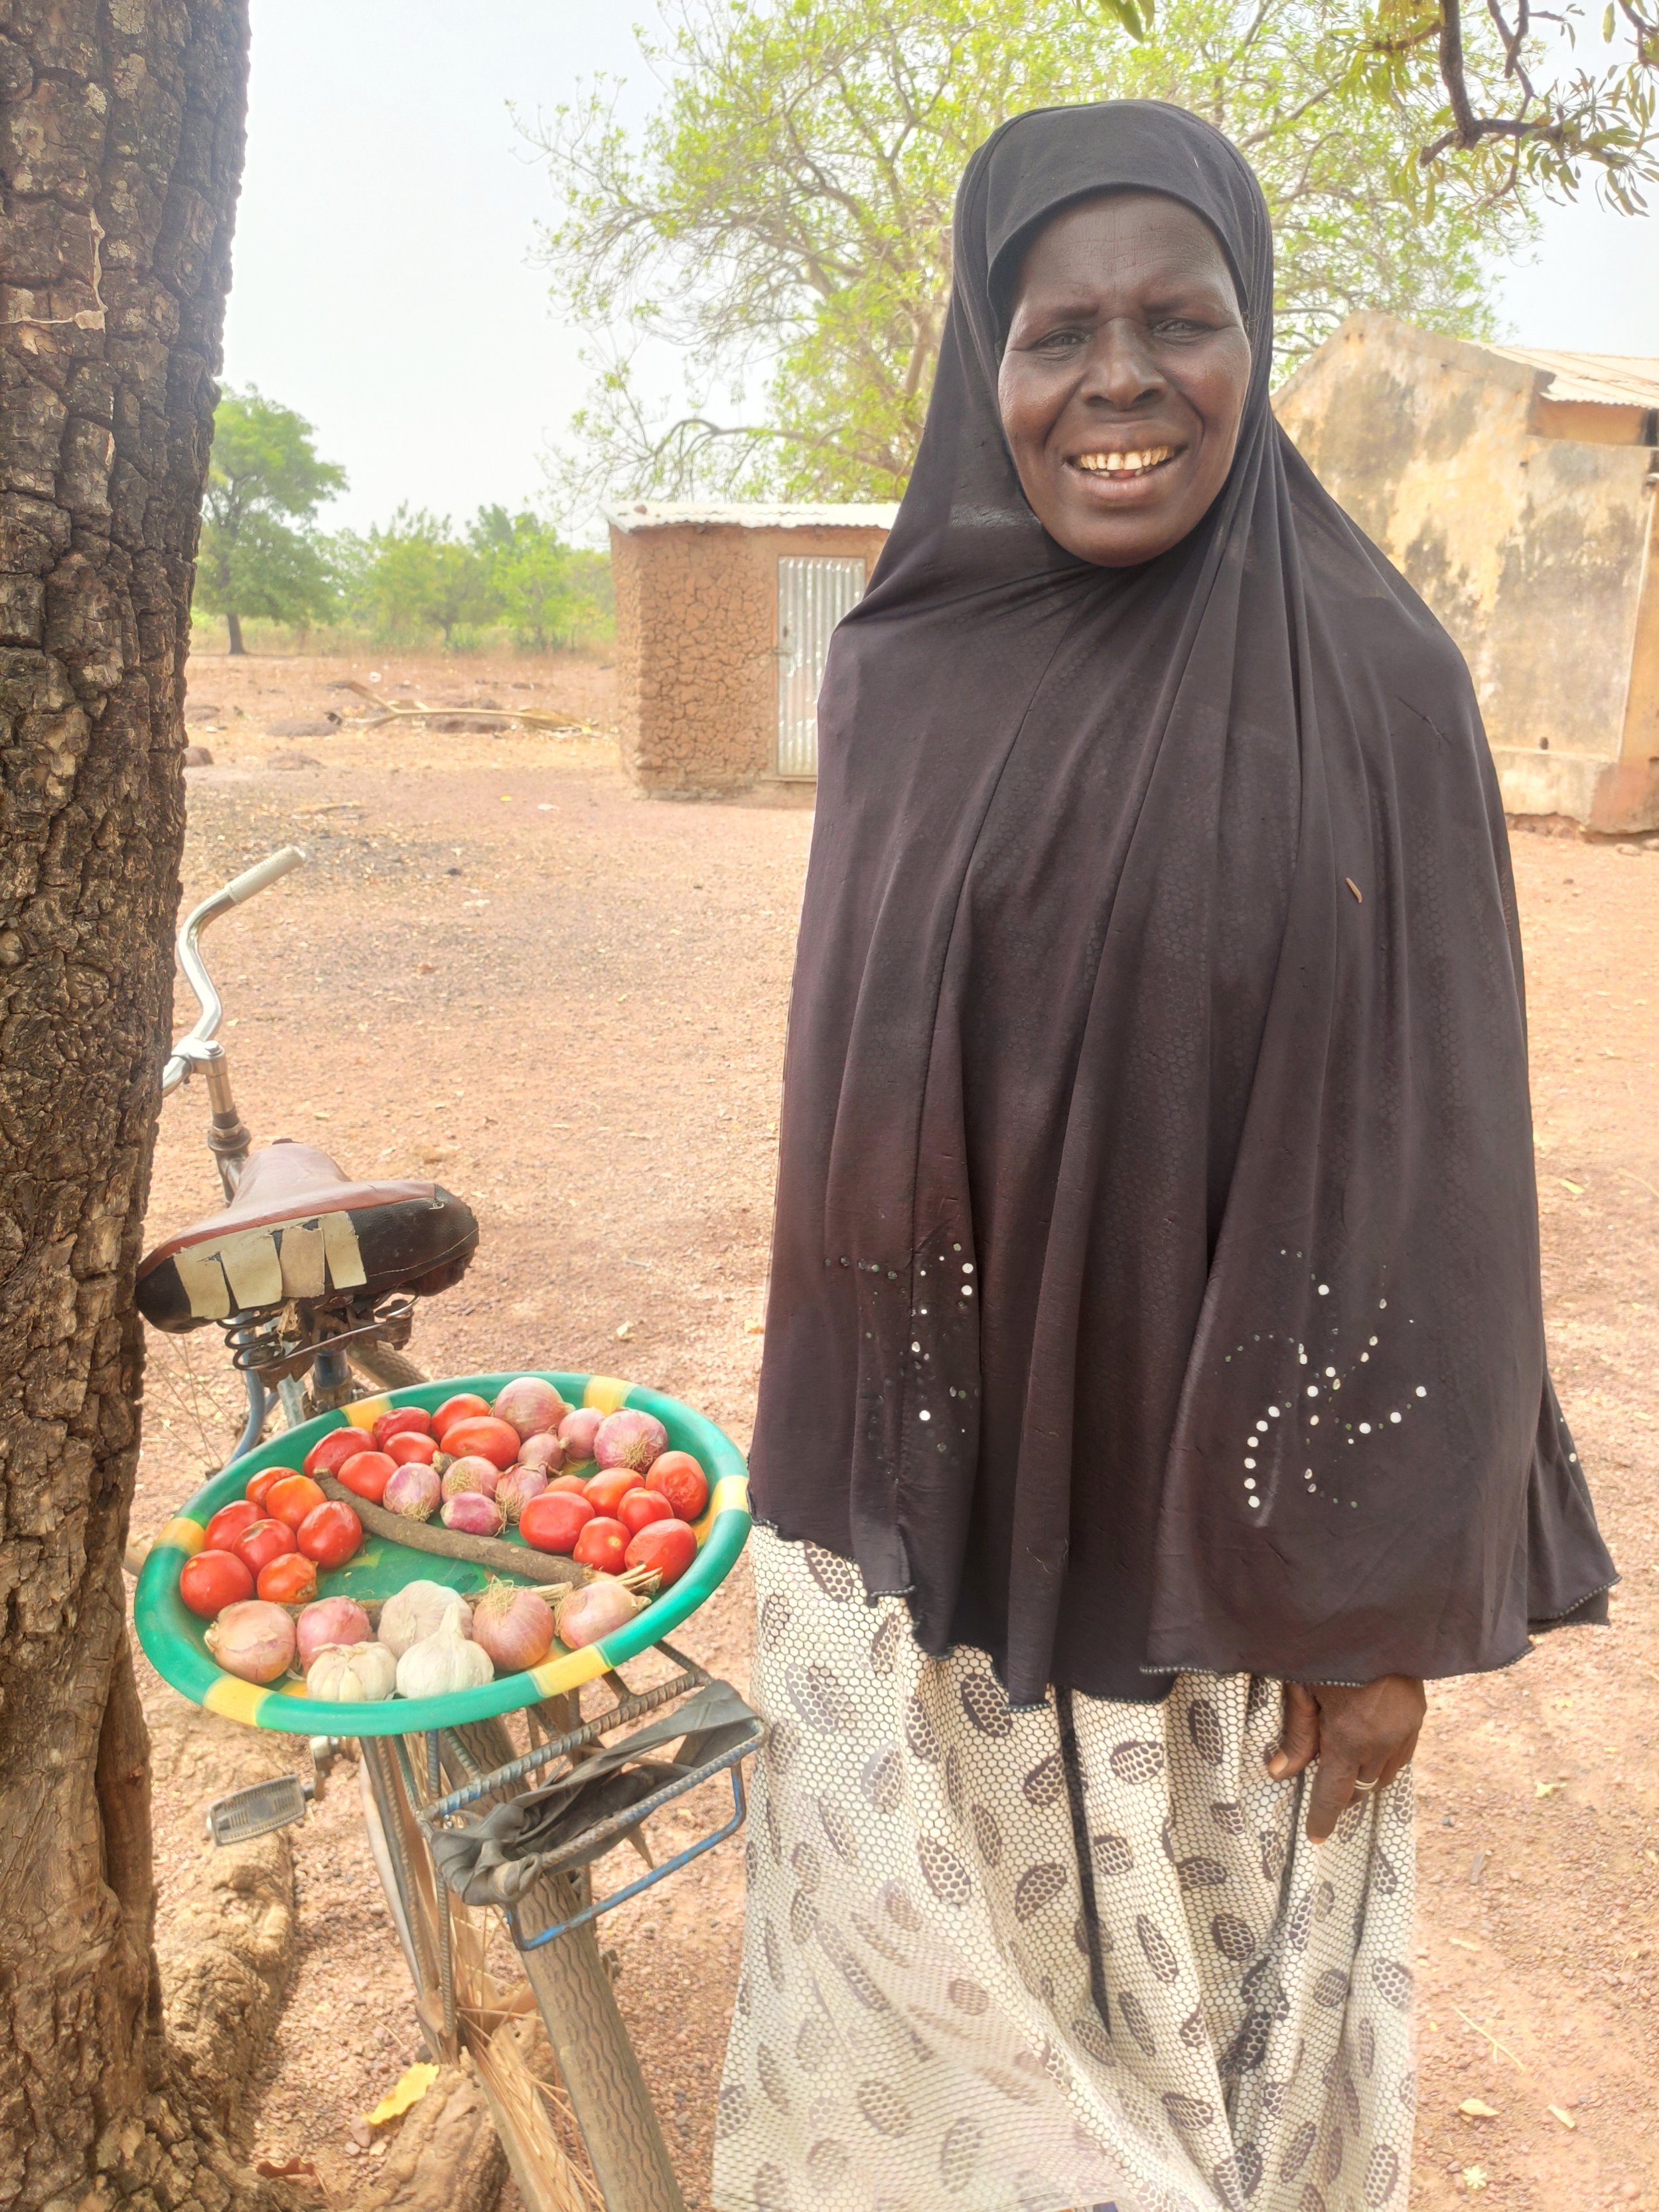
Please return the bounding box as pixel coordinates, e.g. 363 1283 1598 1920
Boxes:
0 0 270 2212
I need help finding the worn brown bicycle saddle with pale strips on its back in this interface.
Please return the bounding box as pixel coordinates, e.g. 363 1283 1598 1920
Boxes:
137 1137 478 1336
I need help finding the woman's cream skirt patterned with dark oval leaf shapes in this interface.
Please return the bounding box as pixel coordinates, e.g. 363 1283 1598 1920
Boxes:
715 1528 1413 2212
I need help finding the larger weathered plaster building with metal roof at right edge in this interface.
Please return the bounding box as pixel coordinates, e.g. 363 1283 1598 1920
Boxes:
1274 314 1659 832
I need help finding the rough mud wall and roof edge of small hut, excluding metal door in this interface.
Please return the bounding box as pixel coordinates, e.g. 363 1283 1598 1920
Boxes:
611 522 887 798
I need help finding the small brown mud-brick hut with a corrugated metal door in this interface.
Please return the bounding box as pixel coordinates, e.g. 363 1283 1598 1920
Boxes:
606 500 898 798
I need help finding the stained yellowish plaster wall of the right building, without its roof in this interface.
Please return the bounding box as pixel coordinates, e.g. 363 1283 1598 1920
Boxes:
1274 314 1648 769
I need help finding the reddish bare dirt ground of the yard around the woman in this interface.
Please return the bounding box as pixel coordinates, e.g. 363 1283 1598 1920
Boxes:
135 655 1659 2212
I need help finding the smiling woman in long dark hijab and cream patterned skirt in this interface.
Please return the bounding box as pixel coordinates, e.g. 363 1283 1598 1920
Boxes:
717 102 1613 2212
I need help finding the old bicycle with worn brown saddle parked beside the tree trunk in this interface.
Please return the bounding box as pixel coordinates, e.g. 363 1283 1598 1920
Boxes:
135 845 761 2212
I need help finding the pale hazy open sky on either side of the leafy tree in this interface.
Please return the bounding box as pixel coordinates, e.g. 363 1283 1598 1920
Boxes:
226 0 1659 526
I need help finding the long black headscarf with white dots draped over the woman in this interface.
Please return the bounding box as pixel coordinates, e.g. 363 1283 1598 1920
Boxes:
752 102 1615 1703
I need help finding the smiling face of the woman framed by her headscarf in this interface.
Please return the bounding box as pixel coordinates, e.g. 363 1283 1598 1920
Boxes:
997 192 1250 569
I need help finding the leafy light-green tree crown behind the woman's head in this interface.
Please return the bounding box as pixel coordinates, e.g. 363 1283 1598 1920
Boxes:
533 0 1659 504
